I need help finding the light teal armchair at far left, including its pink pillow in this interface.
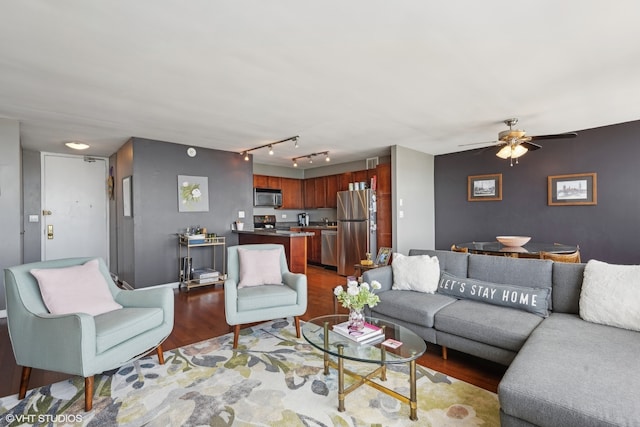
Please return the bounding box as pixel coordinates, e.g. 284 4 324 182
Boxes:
4 258 174 411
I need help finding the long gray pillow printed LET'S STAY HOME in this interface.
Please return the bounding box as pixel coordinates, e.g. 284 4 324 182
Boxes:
438 271 551 317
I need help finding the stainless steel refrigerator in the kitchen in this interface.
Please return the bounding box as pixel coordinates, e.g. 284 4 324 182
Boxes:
337 190 377 276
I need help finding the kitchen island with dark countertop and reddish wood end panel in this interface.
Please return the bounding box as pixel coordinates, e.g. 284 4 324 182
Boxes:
233 229 313 274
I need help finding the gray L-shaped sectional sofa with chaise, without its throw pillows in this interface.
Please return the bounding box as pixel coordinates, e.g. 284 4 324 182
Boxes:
363 250 640 427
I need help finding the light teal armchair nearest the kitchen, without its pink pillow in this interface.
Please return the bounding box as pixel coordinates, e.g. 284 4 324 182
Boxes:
224 244 307 348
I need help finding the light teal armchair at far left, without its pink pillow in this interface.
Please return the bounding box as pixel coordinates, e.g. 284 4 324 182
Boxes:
4 258 174 411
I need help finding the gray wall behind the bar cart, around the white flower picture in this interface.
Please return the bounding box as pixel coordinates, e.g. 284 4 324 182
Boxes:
116 138 253 288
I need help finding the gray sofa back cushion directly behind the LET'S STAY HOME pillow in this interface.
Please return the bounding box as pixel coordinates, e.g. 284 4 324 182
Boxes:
468 254 553 310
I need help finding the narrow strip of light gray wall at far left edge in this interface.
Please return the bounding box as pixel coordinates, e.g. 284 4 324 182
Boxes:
0 119 22 310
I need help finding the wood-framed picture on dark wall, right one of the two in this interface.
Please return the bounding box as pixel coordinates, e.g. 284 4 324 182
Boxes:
547 173 598 206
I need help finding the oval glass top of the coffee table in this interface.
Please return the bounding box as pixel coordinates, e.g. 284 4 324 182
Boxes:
302 314 427 364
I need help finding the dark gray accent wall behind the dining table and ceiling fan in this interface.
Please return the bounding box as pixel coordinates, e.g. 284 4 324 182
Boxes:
435 121 640 264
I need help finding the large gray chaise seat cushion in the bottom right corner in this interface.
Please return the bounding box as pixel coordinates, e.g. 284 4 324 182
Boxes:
498 313 640 427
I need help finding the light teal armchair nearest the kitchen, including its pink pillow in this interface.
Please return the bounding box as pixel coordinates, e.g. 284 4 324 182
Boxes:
224 244 307 348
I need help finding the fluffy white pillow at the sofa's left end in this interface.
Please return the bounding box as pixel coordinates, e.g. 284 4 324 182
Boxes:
391 253 440 294
